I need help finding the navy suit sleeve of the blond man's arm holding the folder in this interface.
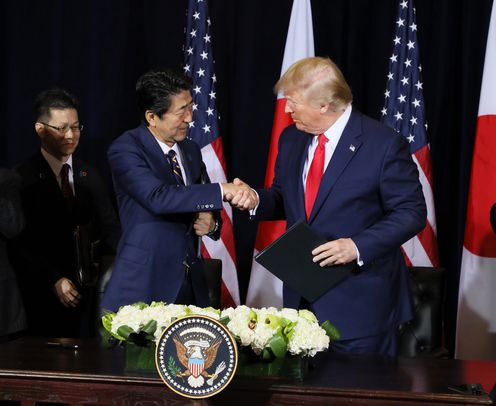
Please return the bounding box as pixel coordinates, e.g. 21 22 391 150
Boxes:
350 136 427 264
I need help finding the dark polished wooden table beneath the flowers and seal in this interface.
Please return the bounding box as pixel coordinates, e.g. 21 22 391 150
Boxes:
0 338 496 406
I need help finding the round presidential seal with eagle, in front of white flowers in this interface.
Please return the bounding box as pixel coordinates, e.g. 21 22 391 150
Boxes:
155 315 238 399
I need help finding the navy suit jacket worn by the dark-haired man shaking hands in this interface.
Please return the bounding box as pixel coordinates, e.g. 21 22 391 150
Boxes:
102 125 222 311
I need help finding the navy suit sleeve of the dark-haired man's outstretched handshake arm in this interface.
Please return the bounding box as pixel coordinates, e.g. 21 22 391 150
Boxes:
108 137 222 215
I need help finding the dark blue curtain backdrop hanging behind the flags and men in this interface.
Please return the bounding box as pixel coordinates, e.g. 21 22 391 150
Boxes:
0 0 492 356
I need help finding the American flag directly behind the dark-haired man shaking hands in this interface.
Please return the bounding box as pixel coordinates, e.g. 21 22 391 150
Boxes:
183 0 239 307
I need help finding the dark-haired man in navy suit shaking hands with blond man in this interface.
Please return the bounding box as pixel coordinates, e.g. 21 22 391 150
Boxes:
102 71 246 311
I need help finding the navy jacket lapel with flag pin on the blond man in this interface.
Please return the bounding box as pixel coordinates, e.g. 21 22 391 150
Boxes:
308 111 362 223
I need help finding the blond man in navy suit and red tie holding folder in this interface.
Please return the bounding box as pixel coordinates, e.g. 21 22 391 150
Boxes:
229 58 426 355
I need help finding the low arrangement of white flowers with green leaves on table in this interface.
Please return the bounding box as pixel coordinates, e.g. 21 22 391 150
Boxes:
102 302 339 360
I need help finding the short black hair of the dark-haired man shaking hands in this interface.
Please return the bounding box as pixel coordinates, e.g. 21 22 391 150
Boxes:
136 69 192 123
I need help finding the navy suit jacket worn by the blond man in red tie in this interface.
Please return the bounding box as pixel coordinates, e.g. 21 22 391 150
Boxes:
257 111 426 339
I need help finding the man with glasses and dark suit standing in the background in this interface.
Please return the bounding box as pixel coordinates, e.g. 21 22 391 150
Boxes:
11 89 120 337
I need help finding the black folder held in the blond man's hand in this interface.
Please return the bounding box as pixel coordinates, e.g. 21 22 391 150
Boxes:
255 222 356 302
